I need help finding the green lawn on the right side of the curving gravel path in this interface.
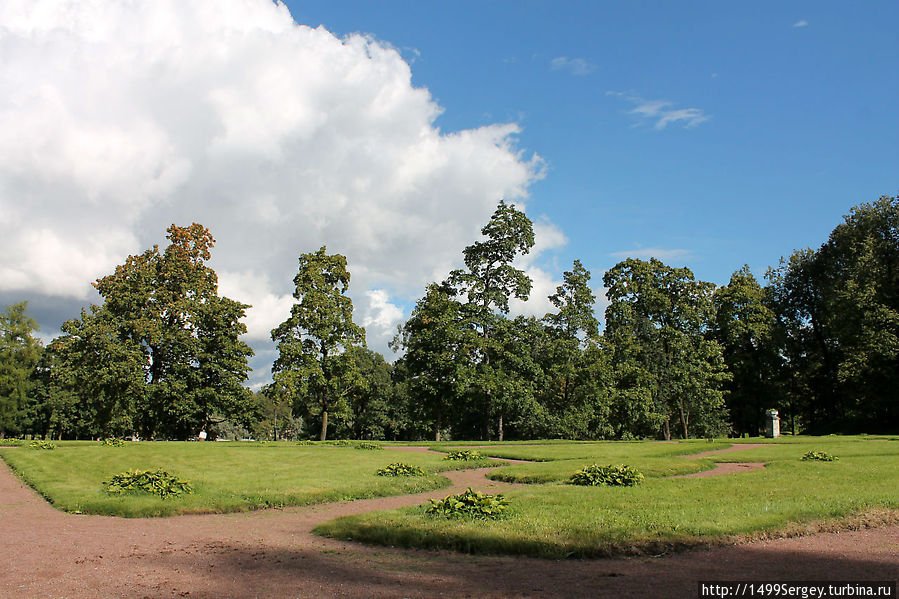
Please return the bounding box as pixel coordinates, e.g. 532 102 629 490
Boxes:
316 437 899 558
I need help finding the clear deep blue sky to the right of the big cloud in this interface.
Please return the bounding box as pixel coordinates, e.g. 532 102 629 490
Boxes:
288 1 899 284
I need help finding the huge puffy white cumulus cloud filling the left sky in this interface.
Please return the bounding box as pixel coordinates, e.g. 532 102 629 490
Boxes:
0 0 542 364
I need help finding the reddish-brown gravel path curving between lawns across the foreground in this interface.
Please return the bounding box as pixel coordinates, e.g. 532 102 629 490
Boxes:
0 448 899 599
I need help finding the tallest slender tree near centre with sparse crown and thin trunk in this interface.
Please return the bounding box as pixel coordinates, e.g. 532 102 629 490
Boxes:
448 201 534 440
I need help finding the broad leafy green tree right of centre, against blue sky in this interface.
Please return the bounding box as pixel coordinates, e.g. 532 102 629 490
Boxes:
603 258 727 439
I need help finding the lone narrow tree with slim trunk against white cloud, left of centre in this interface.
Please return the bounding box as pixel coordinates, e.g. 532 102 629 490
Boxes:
272 246 365 441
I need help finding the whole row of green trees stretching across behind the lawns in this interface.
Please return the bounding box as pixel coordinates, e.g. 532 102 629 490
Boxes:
0 196 899 440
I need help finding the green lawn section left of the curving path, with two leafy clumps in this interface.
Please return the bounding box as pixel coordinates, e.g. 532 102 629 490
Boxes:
0 441 487 517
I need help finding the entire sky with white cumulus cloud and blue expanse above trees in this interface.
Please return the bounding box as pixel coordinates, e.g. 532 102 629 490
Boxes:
0 0 899 385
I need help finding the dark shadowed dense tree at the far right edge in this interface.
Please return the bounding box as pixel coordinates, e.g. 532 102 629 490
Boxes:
768 196 899 432
